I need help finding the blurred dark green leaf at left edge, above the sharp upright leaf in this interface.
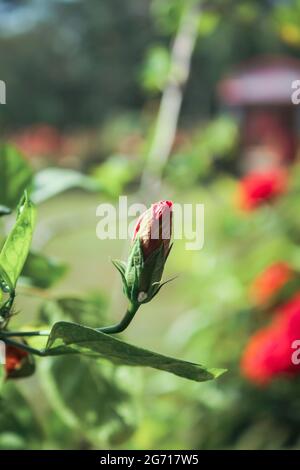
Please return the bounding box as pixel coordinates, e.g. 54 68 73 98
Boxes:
0 144 33 208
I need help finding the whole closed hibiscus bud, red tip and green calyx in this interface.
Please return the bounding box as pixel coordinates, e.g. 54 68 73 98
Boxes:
113 201 173 307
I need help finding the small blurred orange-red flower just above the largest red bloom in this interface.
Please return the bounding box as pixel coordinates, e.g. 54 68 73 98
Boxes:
250 262 294 305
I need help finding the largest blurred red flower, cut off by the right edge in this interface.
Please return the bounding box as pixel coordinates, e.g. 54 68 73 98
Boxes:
241 294 300 384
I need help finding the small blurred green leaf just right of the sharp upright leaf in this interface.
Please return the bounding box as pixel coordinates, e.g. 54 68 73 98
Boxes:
21 252 68 289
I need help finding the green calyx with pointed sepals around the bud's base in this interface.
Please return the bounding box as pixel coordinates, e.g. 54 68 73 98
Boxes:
113 239 172 306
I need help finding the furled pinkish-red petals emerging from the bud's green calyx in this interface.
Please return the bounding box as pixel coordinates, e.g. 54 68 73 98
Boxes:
133 201 173 260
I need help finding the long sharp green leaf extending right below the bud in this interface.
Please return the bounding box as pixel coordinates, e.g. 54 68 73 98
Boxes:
45 322 225 382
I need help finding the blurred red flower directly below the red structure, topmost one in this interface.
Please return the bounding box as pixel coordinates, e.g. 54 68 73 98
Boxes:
238 168 287 211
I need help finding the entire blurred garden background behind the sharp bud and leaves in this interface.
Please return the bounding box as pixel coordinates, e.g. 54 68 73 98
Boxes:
0 0 300 449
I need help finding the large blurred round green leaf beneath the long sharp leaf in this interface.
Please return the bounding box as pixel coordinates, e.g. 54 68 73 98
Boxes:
39 356 137 445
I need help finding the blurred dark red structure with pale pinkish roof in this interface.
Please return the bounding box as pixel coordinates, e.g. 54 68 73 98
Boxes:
219 57 300 172
